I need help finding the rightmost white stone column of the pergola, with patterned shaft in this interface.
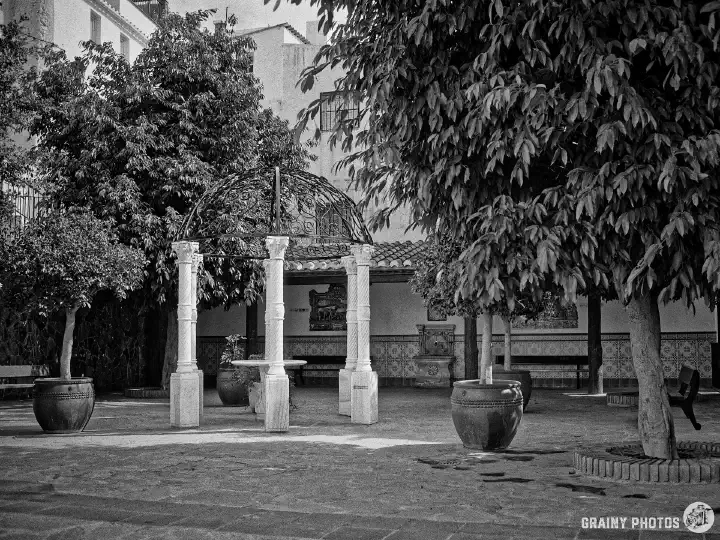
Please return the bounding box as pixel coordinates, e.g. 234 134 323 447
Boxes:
350 244 378 424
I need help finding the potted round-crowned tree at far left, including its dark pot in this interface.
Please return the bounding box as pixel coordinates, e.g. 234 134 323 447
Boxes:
0 209 146 433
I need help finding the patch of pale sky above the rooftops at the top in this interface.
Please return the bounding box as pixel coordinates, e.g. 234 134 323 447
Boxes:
169 0 344 35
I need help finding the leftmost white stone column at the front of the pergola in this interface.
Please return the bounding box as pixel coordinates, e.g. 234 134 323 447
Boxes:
170 242 200 427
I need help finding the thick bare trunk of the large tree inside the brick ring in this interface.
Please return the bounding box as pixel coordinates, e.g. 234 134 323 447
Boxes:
625 294 678 459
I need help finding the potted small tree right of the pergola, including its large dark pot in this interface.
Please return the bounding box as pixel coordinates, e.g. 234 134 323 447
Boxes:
451 196 555 450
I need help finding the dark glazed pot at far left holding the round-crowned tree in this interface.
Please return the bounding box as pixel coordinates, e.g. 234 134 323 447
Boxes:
33 377 95 433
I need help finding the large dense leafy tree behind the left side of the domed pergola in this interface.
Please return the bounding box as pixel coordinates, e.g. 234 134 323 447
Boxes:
26 11 310 386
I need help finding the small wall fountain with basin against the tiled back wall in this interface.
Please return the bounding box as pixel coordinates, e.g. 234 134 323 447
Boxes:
413 324 455 388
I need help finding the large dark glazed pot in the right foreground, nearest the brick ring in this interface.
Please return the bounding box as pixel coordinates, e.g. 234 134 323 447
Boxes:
450 379 523 450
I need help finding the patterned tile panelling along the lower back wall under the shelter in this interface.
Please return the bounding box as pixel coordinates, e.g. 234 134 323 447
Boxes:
198 332 715 387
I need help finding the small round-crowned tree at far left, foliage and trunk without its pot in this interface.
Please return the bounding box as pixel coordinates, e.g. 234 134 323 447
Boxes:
0 212 146 379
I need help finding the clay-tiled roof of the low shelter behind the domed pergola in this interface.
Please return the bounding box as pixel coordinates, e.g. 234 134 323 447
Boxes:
285 241 425 272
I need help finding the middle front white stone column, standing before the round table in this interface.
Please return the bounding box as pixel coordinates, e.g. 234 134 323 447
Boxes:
263 236 290 431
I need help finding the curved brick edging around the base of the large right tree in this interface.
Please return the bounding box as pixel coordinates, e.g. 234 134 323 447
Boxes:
573 441 720 484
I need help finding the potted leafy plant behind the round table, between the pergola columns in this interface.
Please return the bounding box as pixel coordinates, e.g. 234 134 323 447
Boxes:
217 334 260 407
